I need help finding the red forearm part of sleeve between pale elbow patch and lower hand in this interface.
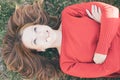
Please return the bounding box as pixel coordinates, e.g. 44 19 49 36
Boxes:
95 18 119 54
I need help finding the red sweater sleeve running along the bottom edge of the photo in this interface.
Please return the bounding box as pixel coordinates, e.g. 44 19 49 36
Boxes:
60 50 119 78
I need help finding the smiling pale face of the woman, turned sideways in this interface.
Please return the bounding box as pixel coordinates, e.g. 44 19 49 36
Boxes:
22 25 56 51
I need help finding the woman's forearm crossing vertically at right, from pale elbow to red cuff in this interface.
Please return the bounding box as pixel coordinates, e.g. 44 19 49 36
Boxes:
95 4 119 55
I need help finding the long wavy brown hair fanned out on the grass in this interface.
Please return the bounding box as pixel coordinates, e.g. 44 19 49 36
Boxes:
2 1 60 80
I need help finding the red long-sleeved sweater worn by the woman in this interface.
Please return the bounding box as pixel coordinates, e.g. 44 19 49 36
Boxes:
60 2 120 78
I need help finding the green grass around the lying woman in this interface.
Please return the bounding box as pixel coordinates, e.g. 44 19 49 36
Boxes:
0 0 120 80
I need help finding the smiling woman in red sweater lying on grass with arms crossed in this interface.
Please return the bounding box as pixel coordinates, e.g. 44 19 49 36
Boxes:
3 2 120 80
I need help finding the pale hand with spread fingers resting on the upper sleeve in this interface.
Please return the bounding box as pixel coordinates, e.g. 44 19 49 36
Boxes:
86 5 101 23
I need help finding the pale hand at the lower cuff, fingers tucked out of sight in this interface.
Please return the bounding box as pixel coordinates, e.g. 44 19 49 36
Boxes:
93 53 107 64
